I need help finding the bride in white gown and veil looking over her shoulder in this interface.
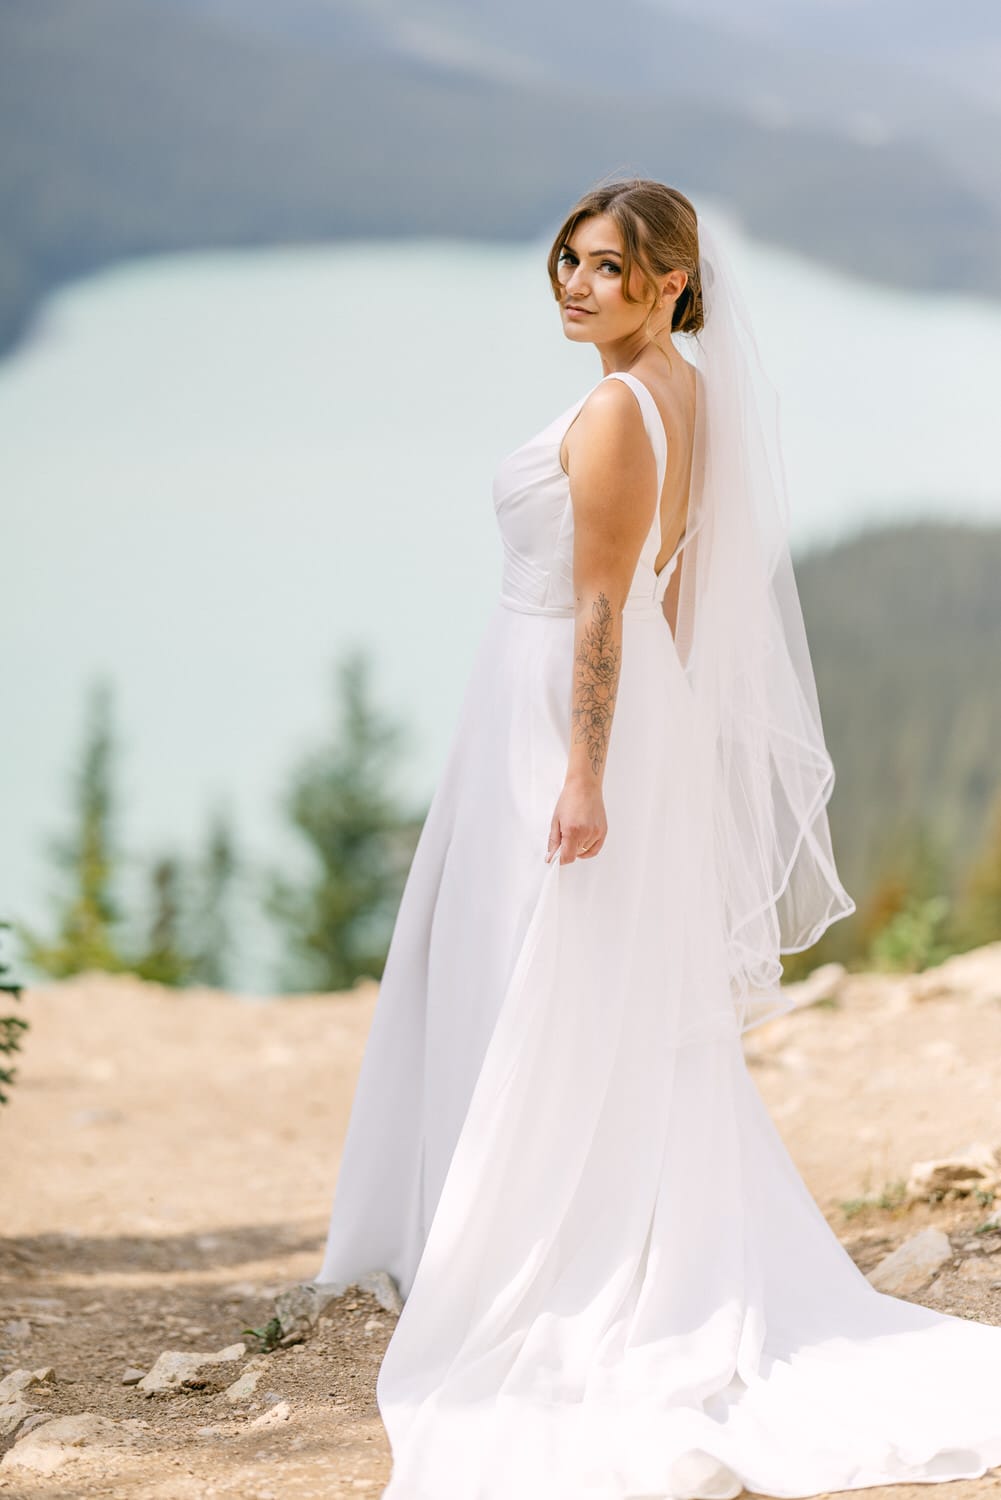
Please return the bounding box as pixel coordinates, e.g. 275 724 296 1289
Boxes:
315 180 1001 1500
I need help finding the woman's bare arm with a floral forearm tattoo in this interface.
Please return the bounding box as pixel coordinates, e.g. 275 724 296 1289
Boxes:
546 381 660 864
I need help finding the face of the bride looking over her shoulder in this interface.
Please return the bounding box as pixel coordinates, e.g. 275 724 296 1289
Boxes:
557 213 687 345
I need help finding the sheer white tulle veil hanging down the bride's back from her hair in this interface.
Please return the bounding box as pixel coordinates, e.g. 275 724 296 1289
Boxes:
674 219 855 1031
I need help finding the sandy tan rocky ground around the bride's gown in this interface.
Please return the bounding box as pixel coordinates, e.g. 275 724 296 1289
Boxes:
0 944 1001 1500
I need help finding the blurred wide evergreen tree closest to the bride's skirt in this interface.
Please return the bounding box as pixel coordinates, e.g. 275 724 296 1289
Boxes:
264 651 420 990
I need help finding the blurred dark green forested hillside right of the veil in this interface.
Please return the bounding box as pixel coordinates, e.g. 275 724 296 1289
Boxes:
795 522 1001 906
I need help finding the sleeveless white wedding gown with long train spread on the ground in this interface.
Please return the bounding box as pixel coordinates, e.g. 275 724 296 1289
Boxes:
315 372 1001 1500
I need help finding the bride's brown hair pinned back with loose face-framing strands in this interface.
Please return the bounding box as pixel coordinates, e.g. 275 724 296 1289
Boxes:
546 177 702 333
